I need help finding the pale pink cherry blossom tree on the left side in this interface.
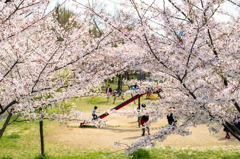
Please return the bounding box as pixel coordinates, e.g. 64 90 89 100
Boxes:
0 0 125 136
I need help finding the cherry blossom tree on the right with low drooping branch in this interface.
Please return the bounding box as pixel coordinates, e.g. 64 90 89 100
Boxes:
74 0 240 153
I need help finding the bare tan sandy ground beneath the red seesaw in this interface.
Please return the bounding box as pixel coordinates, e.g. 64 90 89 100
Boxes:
45 112 239 151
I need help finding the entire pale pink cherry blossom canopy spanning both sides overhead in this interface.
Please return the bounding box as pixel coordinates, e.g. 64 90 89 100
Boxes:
0 0 240 157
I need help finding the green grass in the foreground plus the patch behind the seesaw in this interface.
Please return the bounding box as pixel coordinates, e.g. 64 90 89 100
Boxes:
0 84 240 159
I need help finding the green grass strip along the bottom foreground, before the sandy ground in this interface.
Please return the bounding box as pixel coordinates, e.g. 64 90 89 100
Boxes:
0 105 240 159
